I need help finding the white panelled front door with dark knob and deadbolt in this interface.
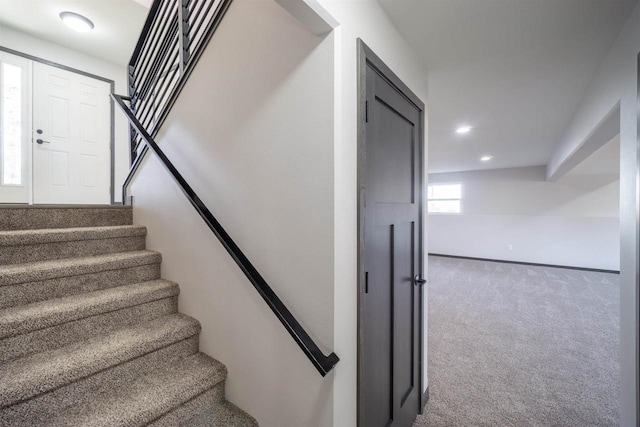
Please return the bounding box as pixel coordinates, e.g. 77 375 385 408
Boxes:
32 62 111 204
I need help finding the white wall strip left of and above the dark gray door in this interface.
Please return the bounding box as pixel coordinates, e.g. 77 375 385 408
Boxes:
308 0 428 427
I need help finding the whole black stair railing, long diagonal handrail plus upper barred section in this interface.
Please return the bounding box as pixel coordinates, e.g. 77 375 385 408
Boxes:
117 0 339 377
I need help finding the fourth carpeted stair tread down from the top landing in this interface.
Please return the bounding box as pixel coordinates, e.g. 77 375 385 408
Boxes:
0 314 200 408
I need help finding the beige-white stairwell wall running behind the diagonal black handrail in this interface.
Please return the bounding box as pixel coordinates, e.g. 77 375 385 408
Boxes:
131 0 334 427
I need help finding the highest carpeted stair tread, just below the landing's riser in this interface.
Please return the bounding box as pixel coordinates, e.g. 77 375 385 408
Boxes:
0 225 147 247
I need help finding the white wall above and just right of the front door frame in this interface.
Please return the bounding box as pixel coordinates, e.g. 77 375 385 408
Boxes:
0 26 129 202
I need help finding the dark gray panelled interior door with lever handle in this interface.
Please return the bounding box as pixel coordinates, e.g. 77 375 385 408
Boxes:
360 57 423 427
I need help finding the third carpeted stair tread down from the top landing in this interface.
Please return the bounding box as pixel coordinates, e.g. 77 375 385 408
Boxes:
0 280 180 339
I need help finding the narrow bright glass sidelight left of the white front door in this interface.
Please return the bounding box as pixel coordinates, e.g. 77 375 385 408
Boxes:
0 52 31 203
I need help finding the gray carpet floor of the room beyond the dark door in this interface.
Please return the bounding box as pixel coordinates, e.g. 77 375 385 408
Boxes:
414 257 620 427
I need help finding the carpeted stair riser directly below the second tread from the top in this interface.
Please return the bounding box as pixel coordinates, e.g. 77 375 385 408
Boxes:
0 263 160 309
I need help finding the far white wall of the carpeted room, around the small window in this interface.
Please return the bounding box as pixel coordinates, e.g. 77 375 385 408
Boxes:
428 165 620 270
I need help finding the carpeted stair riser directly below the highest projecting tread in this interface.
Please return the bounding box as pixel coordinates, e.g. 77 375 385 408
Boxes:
0 236 145 265
